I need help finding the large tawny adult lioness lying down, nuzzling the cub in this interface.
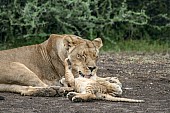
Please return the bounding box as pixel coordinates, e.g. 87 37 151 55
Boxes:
0 34 102 96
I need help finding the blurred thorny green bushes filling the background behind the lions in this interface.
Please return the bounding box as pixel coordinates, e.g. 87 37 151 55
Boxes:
0 0 170 49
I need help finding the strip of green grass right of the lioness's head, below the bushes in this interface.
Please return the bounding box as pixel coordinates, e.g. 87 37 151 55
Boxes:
102 40 170 52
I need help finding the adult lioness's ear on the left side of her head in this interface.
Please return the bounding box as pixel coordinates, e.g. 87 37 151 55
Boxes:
63 35 82 52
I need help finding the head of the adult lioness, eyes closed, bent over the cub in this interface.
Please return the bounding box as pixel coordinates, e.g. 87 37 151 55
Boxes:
64 35 103 78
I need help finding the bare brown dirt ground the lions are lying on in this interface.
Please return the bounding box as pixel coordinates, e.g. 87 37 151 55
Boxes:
0 53 170 113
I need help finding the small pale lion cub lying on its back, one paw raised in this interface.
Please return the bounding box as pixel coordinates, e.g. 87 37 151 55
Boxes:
65 58 144 102
